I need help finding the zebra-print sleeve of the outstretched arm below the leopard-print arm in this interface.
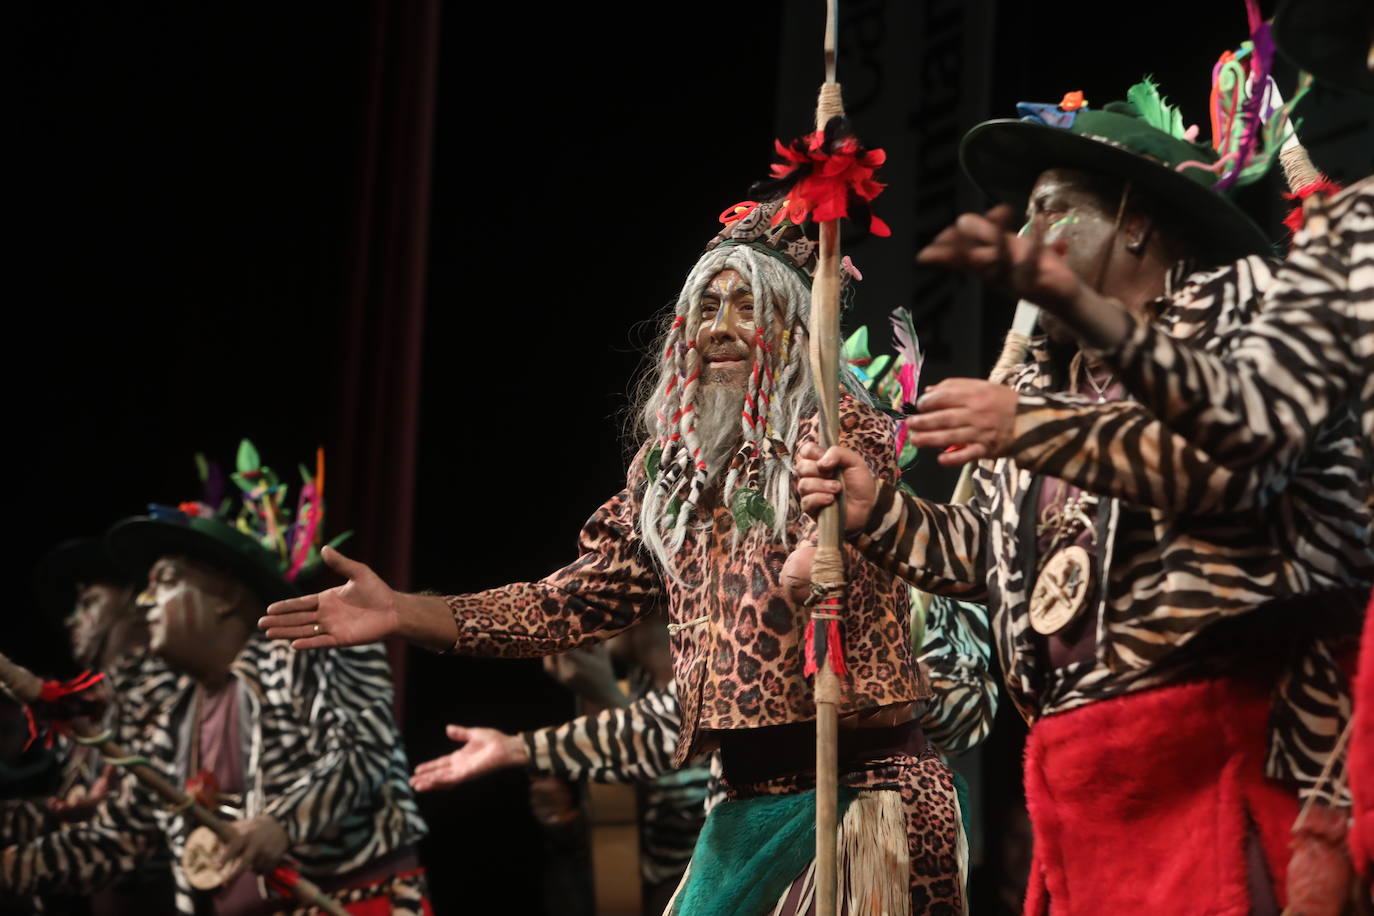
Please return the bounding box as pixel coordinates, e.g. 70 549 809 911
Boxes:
521 683 682 783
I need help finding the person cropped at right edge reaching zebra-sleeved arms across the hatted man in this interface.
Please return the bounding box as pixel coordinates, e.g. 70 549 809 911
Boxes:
890 0 1374 878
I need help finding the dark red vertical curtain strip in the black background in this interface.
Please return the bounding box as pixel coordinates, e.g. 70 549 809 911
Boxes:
331 0 440 718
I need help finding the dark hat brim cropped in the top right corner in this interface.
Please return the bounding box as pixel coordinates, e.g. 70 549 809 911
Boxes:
1274 0 1374 95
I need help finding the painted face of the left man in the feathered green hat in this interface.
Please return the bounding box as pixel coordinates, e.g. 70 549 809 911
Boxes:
139 556 232 667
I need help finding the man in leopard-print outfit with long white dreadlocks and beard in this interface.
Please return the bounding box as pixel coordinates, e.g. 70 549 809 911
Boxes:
260 202 967 916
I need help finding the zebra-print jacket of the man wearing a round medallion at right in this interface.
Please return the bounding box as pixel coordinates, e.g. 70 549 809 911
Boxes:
857 252 1374 788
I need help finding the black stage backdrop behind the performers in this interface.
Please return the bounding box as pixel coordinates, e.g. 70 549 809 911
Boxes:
13 0 1297 913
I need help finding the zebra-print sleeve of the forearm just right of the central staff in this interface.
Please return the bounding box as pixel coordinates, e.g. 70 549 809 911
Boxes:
853 479 988 602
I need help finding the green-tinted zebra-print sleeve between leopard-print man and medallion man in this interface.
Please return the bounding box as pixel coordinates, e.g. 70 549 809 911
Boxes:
921 596 998 754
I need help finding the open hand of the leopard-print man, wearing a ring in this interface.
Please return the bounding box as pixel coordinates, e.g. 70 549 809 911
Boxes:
258 547 400 648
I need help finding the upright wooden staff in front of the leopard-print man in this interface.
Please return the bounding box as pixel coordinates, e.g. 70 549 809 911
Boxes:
808 0 845 916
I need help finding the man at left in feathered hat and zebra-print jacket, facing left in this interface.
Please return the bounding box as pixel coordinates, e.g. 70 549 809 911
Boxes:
0 442 429 916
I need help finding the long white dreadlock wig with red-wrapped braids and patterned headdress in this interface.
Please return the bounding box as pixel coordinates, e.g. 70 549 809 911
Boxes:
640 202 829 573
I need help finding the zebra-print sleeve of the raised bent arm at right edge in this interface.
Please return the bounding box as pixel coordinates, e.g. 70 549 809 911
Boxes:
1103 177 1374 474
